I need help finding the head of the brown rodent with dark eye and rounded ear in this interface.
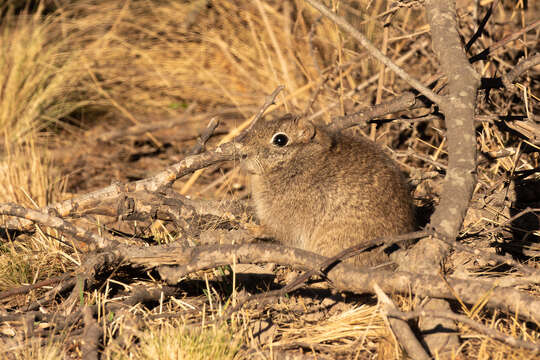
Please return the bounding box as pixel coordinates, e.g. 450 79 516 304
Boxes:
241 114 331 175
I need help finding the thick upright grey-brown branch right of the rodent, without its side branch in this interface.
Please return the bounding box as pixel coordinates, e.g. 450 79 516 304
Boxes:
400 0 480 354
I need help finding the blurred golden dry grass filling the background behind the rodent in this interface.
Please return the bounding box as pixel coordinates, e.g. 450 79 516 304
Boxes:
0 0 419 206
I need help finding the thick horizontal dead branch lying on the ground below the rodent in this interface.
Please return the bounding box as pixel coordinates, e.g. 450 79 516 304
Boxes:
103 244 540 321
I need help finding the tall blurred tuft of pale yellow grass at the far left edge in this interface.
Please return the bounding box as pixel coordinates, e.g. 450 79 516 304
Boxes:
0 6 90 207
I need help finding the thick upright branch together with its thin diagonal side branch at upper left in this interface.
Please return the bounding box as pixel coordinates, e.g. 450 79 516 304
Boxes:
307 0 480 350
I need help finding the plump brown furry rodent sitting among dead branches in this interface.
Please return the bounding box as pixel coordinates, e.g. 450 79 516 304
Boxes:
241 114 415 265
